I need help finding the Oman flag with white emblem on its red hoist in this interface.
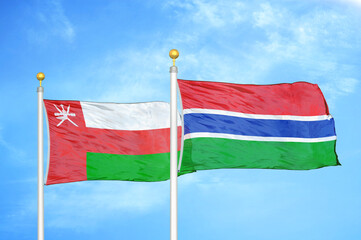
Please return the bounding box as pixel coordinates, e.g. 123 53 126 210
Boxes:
44 100 181 185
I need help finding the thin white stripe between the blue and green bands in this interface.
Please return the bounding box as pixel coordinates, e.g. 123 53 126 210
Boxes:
184 132 336 143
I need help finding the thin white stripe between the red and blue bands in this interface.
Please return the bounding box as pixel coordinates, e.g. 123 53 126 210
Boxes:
183 108 332 121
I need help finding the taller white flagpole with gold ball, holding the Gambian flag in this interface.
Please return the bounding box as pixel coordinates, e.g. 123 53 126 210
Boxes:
169 49 179 240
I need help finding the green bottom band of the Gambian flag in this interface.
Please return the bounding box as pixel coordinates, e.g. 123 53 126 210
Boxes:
181 138 340 172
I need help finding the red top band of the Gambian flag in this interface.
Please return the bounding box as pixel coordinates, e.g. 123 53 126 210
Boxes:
178 79 329 116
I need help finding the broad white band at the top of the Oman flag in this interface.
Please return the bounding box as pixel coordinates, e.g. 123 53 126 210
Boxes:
80 102 181 131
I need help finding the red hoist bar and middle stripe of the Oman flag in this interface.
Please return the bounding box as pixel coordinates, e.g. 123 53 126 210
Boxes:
44 100 181 185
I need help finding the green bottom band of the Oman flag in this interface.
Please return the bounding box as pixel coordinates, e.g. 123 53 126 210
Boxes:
87 152 190 182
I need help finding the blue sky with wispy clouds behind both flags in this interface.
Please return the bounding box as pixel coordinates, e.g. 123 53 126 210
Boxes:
0 0 361 240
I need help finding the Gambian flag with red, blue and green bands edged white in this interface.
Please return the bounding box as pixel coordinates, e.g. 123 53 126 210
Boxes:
178 80 340 172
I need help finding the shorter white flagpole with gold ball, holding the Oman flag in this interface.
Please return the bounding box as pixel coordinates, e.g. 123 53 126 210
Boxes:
36 72 45 240
